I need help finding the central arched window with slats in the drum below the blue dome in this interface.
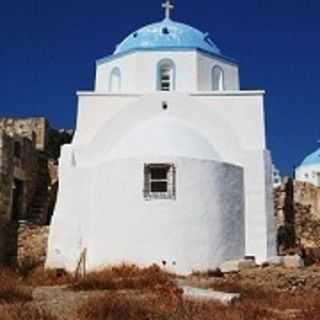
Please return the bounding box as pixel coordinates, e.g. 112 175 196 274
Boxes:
157 59 176 91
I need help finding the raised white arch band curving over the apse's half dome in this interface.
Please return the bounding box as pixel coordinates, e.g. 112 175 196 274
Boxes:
75 93 243 166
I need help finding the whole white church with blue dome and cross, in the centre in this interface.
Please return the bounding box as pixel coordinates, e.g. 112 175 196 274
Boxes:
46 1 276 274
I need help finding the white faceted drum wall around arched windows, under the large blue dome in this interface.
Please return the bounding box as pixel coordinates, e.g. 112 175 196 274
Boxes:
95 51 239 93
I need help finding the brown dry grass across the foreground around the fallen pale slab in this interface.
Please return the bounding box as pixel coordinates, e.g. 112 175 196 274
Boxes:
78 273 320 320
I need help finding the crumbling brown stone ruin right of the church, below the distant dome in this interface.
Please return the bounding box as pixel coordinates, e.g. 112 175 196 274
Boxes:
274 178 320 263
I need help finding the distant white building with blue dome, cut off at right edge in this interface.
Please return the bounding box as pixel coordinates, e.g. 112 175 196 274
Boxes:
295 143 320 187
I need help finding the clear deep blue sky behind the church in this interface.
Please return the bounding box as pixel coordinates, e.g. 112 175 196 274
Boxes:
0 0 320 174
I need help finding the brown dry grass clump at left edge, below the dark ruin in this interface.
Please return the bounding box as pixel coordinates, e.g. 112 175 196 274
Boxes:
0 270 32 304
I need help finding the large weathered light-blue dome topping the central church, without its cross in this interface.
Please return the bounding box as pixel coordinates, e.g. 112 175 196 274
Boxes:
114 19 221 55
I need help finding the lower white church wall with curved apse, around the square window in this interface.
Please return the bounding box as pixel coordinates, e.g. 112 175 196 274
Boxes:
47 157 245 274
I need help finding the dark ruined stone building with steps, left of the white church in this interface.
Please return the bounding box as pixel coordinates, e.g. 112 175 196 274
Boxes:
0 118 73 264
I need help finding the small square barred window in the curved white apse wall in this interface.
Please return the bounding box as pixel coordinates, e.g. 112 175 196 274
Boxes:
144 163 176 200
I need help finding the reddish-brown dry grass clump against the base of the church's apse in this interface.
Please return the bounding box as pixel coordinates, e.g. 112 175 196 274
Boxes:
71 264 178 291
